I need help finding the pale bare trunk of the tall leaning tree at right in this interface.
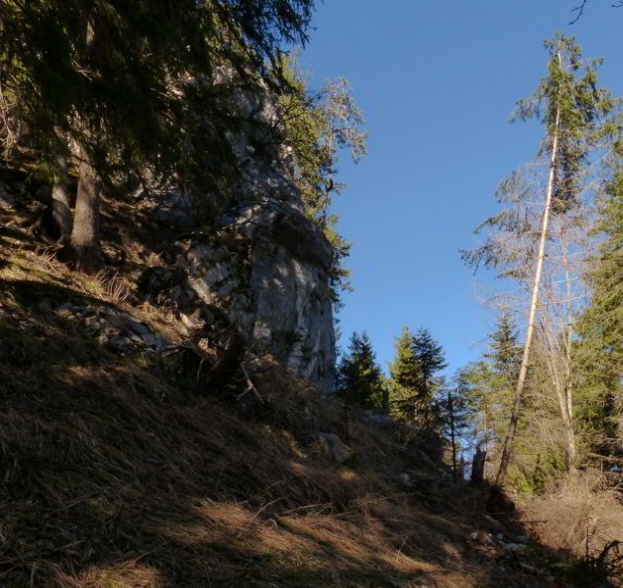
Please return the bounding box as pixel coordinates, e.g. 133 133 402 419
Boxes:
495 102 560 486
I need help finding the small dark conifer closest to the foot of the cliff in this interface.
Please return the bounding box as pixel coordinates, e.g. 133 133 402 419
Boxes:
337 332 384 410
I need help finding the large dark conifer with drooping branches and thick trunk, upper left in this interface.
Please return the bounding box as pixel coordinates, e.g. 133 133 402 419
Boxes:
0 0 313 270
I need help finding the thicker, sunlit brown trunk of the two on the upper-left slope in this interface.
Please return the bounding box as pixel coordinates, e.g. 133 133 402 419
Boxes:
69 155 102 273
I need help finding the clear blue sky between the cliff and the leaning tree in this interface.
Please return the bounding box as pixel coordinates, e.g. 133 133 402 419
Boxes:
301 0 623 374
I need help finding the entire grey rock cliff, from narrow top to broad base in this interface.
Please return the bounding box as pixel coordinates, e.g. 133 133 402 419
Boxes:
154 78 335 390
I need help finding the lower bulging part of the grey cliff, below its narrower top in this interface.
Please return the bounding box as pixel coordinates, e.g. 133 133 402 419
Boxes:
187 206 335 390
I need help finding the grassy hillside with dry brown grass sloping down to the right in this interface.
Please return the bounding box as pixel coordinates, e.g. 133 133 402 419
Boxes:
0 191 620 588
